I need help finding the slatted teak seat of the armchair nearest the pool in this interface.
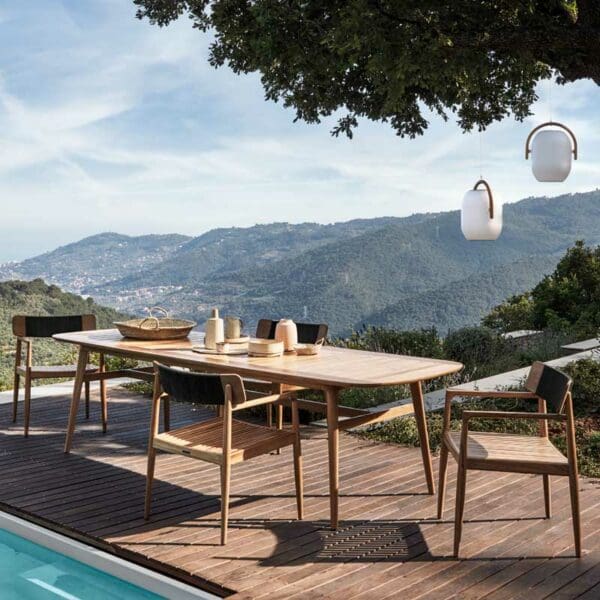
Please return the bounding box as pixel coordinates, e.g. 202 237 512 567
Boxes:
154 418 294 465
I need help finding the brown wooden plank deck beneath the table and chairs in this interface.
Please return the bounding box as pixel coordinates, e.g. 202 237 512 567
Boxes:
0 391 600 600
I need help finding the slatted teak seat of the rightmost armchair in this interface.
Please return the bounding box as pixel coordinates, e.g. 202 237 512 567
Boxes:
446 431 569 475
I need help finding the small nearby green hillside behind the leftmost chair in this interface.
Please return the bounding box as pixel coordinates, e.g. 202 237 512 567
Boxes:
0 279 123 390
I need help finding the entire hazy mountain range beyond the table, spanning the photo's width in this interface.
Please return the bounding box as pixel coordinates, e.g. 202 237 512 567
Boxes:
0 190 600 334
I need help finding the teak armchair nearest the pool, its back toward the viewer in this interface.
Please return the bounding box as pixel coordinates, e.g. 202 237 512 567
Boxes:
144 363 304 545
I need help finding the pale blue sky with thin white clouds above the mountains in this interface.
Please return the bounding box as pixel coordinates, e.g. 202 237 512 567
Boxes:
0 0 600 262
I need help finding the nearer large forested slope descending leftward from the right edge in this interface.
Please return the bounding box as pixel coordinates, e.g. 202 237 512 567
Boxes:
158 192 600 334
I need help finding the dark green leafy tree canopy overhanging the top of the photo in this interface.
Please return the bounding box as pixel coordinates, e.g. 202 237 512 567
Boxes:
134 0 600 137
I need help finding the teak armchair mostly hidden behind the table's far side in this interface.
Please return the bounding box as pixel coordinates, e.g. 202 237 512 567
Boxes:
251 319 329 429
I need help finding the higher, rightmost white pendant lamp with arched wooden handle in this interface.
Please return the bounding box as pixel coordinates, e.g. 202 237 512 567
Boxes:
525 121 577 182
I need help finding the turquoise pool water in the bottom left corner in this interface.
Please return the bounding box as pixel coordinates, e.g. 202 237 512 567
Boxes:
0 529 162 600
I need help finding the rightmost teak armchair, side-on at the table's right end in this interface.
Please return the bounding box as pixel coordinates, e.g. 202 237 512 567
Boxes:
438 362 581 557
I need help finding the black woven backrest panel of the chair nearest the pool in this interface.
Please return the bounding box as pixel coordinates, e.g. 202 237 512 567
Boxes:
157 365 225 405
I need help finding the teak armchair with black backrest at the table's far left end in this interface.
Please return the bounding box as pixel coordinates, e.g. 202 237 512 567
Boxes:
12 315 107 437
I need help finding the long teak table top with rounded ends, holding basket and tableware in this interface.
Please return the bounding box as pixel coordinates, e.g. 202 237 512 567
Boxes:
54 329 462 389
